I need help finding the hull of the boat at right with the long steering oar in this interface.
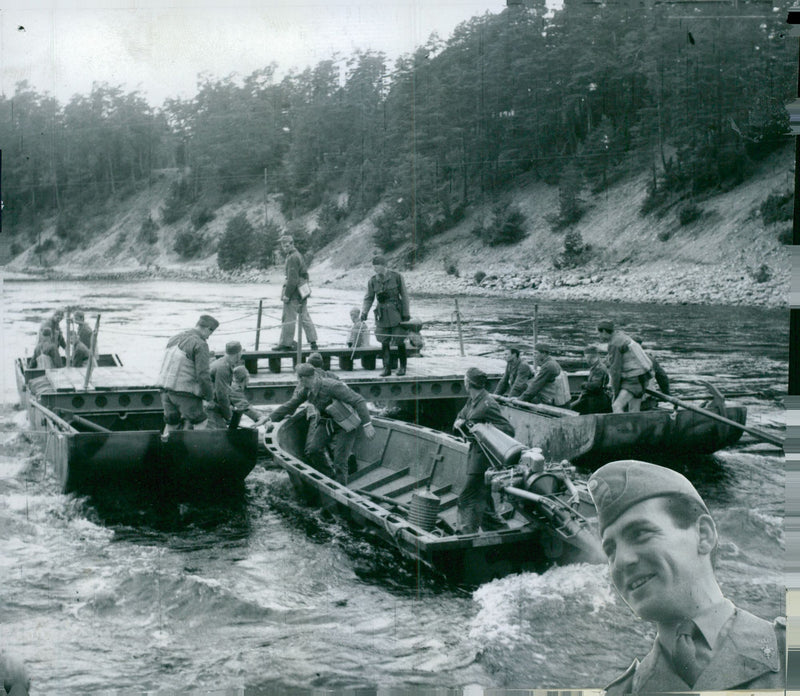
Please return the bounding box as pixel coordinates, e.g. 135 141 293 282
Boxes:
501 402 747 464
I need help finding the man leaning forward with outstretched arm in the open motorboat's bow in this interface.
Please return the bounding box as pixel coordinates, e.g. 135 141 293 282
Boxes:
256 363 375 483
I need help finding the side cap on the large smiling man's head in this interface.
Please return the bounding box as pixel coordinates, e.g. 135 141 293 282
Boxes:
588 459 708 534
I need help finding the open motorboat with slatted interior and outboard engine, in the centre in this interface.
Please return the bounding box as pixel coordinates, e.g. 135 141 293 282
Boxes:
267 412 600 585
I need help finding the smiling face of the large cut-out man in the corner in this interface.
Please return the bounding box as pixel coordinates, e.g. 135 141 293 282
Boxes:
602 498 716 622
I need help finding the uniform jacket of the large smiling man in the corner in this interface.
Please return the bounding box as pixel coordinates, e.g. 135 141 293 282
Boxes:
606 607 786 696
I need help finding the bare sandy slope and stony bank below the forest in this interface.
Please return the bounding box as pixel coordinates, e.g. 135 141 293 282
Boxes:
7 148 793 306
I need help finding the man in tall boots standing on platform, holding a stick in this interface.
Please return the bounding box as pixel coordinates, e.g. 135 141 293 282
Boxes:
361 254 411 377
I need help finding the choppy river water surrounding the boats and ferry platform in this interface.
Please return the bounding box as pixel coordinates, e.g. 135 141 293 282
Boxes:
0 280 788 695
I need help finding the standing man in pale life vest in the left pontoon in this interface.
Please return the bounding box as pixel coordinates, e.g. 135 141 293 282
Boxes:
158 314 219 436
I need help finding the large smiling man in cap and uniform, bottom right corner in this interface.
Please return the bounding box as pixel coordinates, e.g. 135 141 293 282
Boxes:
589 460 786 696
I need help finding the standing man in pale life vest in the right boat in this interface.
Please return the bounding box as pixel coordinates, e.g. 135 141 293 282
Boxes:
597 320 653 413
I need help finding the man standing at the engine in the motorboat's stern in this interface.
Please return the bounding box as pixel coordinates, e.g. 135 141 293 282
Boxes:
453 367 514 534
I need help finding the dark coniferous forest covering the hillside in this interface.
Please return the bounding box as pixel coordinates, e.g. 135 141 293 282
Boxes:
0 2 798 266
